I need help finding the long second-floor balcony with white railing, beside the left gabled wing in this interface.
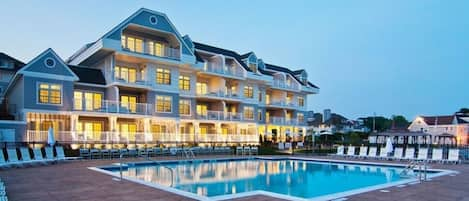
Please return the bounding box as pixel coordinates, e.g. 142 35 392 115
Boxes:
73 100 153 115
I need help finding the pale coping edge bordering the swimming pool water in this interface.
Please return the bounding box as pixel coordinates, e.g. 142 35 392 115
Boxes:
88 156 459 201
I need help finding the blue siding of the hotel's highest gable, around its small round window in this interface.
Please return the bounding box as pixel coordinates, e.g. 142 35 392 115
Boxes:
108 11 192 55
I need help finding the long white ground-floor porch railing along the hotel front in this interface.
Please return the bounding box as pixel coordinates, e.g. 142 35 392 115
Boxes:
25 130 259 144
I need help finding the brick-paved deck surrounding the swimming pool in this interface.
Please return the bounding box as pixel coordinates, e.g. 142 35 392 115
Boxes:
0 156 469 201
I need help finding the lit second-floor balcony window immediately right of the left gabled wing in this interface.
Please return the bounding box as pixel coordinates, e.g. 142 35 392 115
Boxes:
73 91 103 111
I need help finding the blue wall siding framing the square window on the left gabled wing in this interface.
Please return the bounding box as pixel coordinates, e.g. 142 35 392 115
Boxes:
24 76 73 111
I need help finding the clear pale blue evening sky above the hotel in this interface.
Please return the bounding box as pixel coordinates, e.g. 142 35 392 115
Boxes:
0 0 469 118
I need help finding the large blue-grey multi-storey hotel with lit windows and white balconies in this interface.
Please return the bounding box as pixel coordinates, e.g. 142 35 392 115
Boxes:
0 8 319 148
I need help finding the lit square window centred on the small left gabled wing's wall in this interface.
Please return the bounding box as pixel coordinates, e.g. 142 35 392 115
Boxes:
38 83 62 105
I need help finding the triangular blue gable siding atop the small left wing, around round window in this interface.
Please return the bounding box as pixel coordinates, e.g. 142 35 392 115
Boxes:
24 52 74 77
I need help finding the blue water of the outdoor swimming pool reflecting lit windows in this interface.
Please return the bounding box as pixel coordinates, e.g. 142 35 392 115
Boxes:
93 158 448 200
